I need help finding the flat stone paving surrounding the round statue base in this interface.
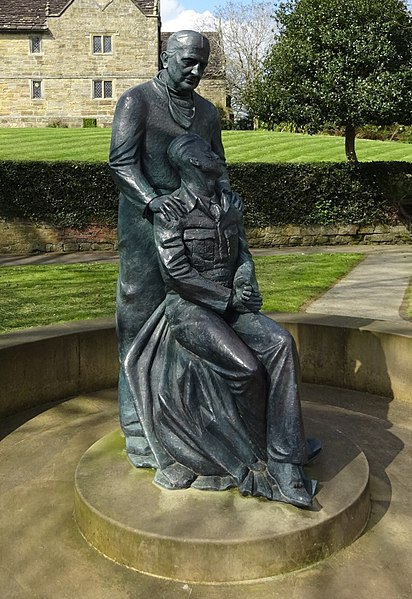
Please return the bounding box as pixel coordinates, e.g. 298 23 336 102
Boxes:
0 385 412 599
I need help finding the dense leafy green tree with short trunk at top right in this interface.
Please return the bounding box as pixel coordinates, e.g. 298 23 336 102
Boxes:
247 0 412 161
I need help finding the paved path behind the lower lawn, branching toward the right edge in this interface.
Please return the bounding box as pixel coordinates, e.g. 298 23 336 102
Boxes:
0 244 412 320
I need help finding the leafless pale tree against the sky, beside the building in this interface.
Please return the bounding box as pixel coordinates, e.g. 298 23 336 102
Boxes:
201 0 274 117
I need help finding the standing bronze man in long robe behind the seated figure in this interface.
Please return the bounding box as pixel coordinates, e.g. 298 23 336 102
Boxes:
110 31 231 467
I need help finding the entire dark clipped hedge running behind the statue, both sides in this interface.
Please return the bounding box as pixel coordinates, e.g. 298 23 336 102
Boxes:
0 161 412 228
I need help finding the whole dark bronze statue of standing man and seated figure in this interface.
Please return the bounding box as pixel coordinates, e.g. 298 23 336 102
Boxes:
111 31 320 507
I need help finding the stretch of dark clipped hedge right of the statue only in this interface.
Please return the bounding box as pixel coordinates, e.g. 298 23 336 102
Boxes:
229 162 412 227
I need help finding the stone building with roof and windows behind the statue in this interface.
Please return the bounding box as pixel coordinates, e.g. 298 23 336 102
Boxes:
0 0 226 127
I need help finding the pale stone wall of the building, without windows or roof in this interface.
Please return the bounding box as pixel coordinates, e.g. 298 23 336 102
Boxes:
0 0 159 127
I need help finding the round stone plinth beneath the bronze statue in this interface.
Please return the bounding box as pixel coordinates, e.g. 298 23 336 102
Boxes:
75 422 370 583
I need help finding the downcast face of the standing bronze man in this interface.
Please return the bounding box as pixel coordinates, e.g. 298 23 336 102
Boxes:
162 44 209 92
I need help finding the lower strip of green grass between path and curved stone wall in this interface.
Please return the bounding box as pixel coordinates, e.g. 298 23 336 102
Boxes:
0 254 363 333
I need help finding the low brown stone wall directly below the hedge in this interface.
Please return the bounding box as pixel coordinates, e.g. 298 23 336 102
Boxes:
0 219 412 254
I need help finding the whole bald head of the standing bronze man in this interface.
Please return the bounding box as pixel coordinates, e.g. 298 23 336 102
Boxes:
161 30 210 94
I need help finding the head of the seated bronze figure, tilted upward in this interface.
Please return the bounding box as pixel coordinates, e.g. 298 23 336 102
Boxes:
167 133 223 182
